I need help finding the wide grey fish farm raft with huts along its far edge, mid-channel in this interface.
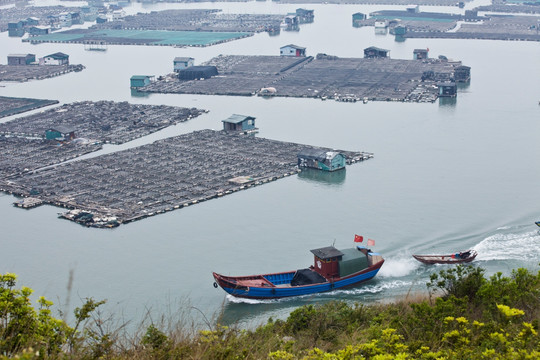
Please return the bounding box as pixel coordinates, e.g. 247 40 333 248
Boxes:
138 54 461 102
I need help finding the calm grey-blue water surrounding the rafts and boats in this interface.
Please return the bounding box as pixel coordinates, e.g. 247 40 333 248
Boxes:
0 2 540 326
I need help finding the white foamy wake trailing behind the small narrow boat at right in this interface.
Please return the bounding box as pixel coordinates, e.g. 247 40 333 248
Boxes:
473 228 540 261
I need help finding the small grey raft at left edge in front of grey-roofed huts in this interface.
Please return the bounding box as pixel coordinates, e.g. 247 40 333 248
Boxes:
0 65 84 82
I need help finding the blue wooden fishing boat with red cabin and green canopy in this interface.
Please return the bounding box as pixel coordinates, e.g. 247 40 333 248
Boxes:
213 246 384 299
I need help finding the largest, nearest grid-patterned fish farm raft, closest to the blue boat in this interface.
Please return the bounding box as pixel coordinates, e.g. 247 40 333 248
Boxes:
0 130 373 227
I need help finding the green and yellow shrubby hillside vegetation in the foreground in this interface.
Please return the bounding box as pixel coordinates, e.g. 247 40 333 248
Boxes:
0 265 540 360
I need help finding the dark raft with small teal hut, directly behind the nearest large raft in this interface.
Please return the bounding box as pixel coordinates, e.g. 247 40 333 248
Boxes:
0 101 205 178
